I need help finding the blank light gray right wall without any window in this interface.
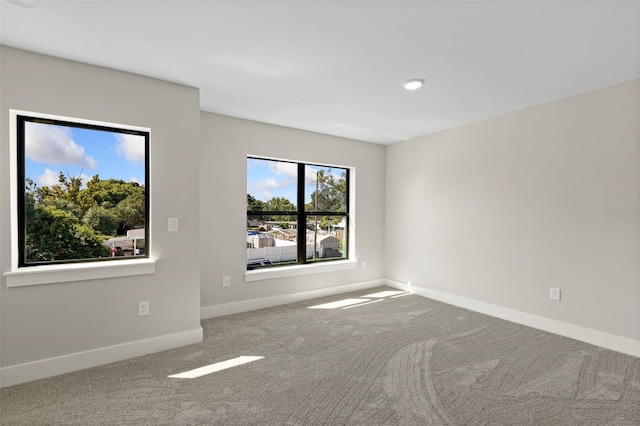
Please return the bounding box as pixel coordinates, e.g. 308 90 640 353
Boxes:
385 80 640 351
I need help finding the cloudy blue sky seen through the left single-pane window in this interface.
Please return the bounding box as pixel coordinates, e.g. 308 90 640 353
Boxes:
25 122 145 186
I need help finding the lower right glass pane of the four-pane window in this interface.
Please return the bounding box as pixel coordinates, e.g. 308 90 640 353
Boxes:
306 216 347 260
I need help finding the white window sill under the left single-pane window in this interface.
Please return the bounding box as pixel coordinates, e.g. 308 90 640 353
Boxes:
4 259 156 287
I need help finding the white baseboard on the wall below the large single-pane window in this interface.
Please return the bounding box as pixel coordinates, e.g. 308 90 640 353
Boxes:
0 327 203 387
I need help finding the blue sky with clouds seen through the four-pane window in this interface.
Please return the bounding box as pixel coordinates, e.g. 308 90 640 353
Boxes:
247 158 340 205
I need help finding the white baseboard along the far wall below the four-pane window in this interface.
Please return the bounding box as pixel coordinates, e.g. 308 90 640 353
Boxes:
200 279 385 319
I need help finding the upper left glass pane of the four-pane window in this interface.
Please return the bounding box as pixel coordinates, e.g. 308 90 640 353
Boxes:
247 158 298 211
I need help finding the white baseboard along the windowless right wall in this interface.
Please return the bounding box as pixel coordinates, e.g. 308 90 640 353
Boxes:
384 279 640 358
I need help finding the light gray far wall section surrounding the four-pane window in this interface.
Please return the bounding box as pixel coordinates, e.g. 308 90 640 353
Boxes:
200 112 384 316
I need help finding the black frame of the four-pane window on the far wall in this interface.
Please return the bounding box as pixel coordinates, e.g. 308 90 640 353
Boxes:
245 155 352 274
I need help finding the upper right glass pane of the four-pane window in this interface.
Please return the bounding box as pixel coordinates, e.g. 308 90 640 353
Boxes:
304 165 347 212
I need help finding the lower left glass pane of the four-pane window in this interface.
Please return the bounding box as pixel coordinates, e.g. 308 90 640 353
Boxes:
247 215 298 269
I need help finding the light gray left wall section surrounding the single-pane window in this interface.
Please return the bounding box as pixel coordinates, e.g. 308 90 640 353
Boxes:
0 47 201 385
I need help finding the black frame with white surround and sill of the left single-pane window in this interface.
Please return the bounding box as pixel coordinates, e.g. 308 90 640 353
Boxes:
3 109 156 287
